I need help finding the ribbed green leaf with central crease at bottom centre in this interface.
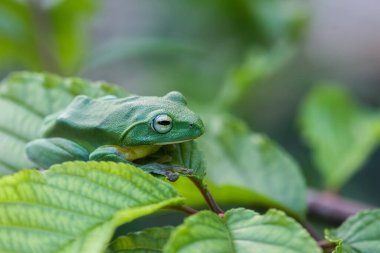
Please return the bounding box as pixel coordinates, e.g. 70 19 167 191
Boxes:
165 208 321 253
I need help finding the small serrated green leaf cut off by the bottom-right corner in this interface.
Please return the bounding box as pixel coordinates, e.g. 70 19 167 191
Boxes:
325 209 380 253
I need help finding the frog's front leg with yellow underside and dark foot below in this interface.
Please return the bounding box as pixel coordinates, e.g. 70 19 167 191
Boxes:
90 145 188 181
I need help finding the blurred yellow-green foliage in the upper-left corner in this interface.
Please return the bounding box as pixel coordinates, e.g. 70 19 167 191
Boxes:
0 0 96 74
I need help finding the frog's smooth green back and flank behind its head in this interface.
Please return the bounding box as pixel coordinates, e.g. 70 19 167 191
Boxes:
42 95 132 147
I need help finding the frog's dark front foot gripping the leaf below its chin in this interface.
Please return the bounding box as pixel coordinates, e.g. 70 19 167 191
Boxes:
139 163 193 182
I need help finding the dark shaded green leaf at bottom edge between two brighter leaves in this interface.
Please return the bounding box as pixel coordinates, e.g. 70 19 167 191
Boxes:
109 227 174 253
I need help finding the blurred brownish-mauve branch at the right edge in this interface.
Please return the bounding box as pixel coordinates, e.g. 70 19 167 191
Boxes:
308 190 373 223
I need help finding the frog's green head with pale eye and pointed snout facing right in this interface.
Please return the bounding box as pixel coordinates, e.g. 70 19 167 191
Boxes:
121 91 204 146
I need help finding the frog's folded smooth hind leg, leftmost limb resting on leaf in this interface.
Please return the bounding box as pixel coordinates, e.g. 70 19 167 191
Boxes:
25 138 89 169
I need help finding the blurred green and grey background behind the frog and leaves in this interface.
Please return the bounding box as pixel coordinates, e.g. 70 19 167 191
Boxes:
0 0 380 208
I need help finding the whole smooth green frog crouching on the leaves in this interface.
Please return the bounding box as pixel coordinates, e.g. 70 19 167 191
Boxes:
26 91 204 180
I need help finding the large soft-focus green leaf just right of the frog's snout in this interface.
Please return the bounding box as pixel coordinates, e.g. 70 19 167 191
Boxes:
194 113 306 216
